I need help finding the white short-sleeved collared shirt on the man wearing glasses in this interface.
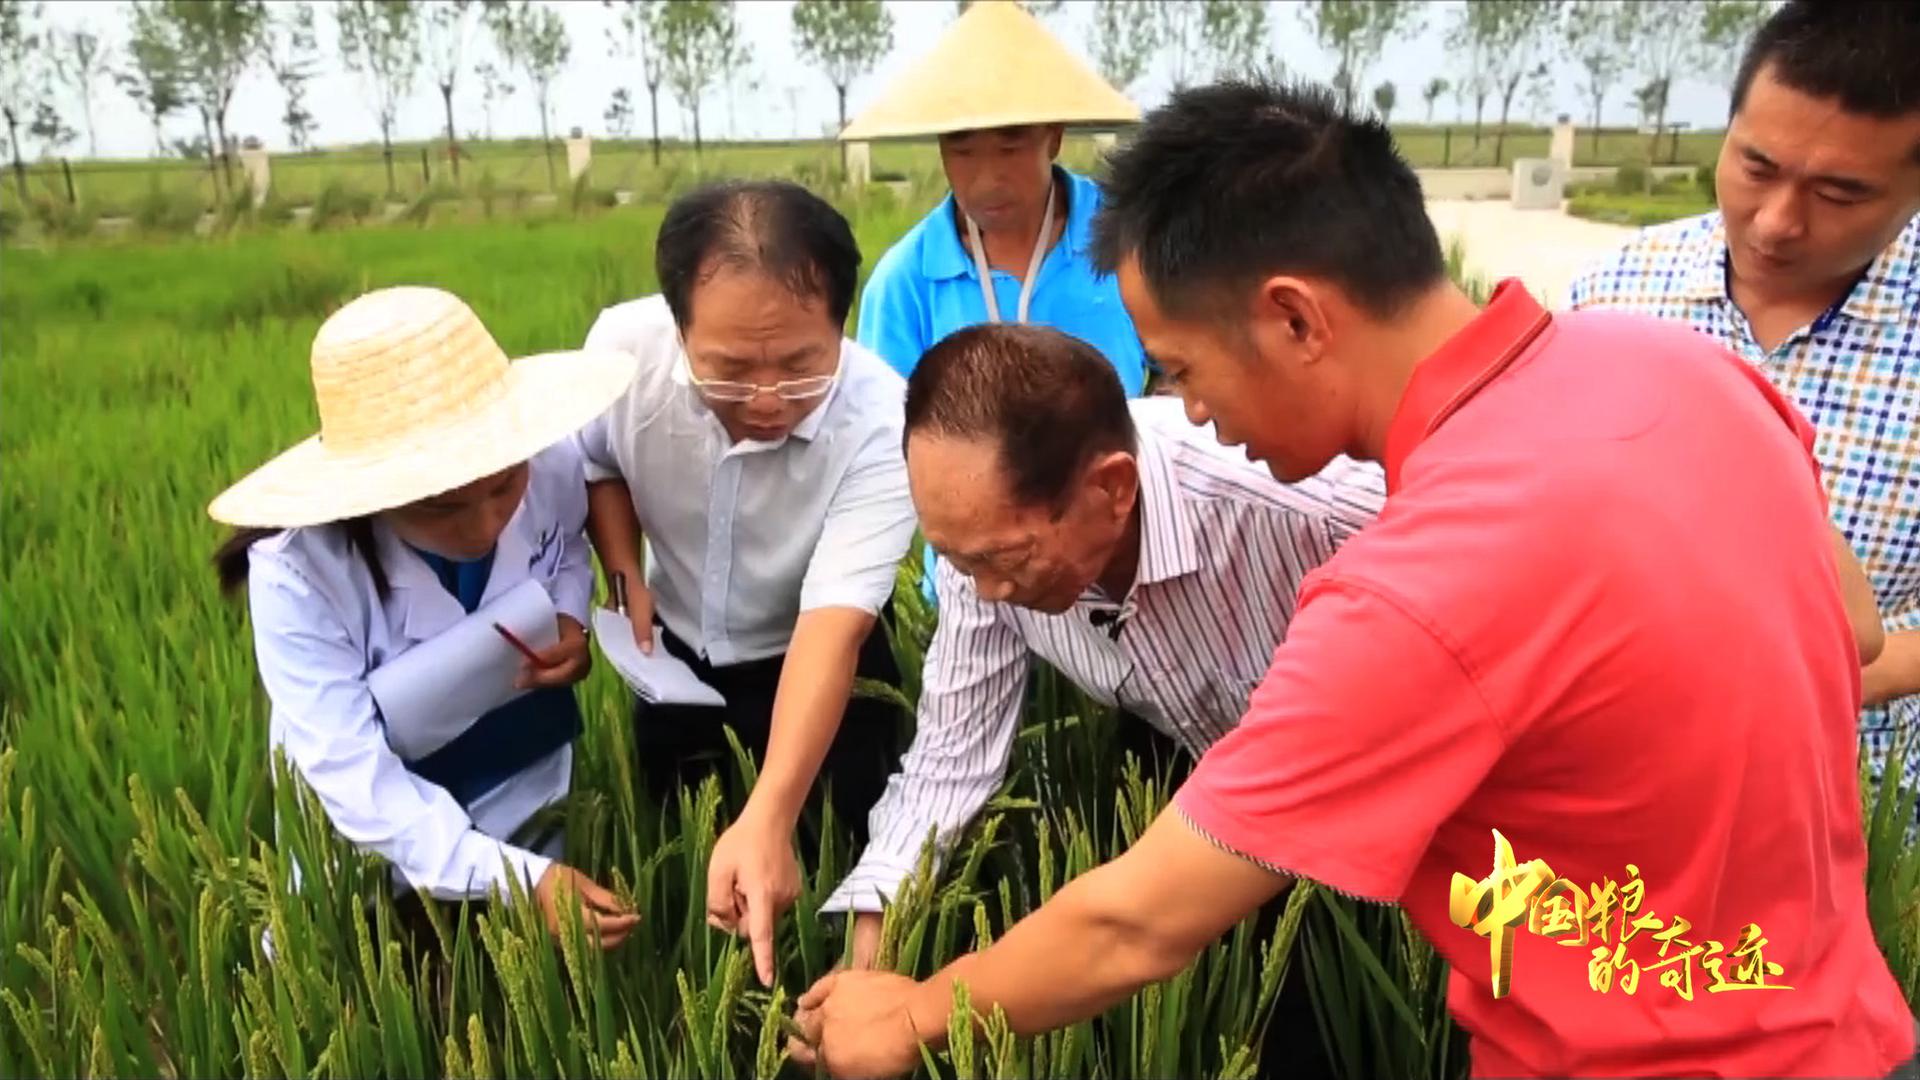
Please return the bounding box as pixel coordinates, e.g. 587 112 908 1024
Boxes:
574 296 916 665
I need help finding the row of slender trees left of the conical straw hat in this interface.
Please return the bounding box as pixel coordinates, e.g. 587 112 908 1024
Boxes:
0 0 753 196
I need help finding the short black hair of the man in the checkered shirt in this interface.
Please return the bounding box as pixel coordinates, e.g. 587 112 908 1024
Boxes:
1730 0 1920 119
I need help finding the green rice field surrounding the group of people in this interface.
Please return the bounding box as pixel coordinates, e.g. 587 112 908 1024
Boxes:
0 200 1920 1078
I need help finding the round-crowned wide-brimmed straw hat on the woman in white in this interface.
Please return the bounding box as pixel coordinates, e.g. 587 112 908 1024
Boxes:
207 288 636 528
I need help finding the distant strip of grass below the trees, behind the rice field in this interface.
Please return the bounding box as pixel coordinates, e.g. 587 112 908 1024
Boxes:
0 125 1720 217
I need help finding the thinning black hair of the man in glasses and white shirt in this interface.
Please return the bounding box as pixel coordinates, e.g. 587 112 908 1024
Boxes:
653 181 860 329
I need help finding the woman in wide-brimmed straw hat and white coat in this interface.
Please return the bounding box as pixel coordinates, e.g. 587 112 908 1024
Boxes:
209 288 637 947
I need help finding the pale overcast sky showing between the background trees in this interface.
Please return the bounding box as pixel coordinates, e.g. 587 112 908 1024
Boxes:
29 0 1726 158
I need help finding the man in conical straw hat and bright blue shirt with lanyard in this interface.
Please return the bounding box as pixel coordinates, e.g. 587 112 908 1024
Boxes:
841 0 1146 398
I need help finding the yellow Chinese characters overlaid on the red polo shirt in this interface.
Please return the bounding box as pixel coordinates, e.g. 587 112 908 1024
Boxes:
1448 828 1791 1001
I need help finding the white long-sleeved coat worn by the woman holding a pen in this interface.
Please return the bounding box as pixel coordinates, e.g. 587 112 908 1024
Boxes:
248 442 593 899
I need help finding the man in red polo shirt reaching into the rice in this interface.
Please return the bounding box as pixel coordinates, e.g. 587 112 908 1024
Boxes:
795 85 1914 1076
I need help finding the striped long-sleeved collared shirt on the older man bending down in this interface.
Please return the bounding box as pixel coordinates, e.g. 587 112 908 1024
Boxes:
822 398 1386 911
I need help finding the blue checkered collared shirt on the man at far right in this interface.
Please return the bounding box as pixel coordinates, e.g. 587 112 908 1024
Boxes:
1567 211 1920 780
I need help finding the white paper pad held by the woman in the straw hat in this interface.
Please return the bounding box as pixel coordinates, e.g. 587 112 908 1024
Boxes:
367 578 561 761
